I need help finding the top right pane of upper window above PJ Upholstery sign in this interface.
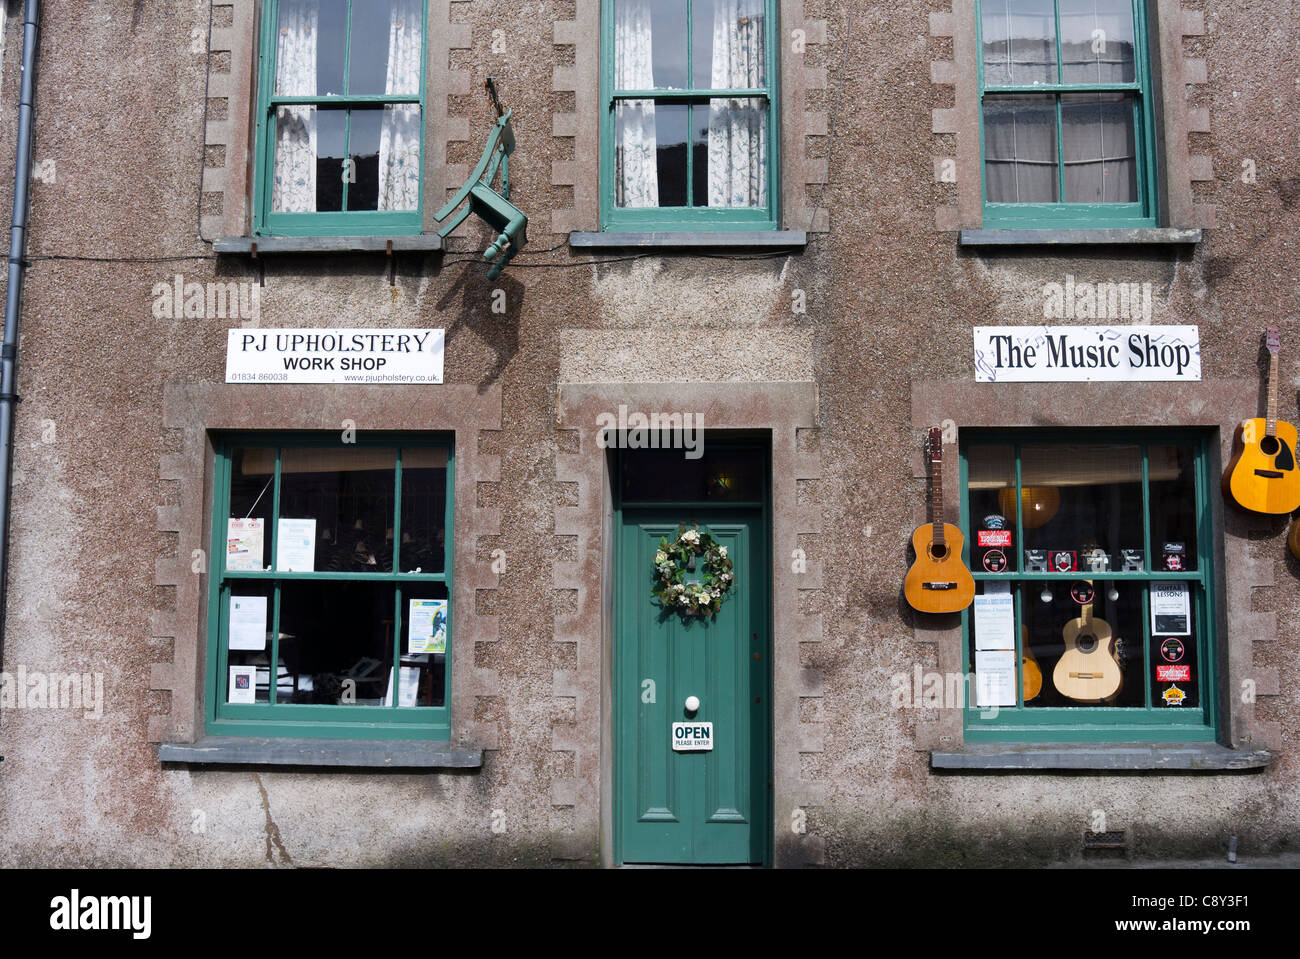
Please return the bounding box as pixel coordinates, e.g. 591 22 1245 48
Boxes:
347 0 424 95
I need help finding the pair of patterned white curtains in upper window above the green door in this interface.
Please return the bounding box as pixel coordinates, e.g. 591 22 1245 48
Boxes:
614 0 767 208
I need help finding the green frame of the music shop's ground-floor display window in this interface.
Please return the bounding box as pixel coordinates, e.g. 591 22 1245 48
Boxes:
959 429 1219 743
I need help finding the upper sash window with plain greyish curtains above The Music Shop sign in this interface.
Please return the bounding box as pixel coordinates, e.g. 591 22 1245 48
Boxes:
978 0 1157 229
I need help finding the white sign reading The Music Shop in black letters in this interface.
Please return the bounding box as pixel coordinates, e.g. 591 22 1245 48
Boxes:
975 326 1201 383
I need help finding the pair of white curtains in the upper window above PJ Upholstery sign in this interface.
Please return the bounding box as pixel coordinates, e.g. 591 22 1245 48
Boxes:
270 0 424 213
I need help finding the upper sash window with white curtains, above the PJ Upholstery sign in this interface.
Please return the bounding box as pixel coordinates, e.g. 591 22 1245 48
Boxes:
255 0 425 235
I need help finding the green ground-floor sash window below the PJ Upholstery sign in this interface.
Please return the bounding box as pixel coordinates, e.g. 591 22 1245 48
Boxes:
207 434 454 739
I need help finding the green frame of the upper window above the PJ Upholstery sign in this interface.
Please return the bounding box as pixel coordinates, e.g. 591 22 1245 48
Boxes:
254 0 429 237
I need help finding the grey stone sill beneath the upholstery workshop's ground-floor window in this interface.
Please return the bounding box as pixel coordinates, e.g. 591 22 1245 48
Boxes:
159 735 484 769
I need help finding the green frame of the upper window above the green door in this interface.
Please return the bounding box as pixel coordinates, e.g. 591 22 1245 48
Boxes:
599 0 781 233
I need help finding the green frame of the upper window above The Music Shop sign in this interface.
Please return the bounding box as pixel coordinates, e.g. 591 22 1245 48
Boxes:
975 0 1158 230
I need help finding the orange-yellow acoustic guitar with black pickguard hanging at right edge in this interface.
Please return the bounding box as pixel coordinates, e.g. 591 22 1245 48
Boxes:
1223 326 1300 513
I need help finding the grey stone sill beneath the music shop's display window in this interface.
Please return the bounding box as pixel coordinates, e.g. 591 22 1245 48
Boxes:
930 742 1277 772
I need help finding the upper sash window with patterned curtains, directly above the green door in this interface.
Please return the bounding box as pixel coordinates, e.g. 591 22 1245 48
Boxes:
601 0 779 230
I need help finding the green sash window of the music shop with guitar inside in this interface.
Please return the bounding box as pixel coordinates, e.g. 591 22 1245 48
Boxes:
961 430 1217 742
